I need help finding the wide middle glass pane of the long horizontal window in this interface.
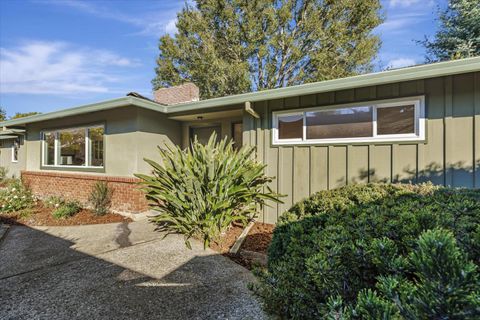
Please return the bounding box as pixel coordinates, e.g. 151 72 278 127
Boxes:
307 107 373 139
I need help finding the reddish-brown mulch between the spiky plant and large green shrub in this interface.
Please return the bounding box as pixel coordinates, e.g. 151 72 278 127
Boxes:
210 222 275 270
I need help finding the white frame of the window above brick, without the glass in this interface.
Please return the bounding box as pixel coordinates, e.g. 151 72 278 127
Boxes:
41 125 105 169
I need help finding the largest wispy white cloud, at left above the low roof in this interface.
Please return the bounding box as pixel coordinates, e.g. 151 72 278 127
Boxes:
0 41 138 94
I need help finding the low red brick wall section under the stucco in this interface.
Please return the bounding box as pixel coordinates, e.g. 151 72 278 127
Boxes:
22 171 148 213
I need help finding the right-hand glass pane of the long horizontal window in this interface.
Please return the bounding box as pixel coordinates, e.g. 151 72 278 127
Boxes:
377 105 415 134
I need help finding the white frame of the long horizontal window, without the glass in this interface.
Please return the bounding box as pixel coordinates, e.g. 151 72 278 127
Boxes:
272 96 425 145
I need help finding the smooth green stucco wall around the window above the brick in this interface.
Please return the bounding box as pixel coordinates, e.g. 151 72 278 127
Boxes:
17 107 181 177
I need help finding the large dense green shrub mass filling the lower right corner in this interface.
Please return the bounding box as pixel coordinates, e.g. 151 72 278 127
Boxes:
253 184 480 319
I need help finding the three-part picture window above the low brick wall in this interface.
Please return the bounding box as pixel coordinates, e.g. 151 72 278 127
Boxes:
42 126 105 168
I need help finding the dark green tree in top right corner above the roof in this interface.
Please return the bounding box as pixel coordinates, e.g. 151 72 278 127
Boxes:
420 0 480 62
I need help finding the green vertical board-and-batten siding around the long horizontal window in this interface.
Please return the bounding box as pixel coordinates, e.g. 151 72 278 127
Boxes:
244 72 480 223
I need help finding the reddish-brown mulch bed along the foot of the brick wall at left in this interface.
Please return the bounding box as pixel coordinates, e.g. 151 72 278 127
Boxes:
0 203 132 226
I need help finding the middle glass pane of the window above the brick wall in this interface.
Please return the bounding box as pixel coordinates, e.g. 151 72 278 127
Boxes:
59 128 85 166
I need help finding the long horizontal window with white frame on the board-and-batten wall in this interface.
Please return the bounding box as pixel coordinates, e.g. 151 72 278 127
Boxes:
273 96 425 144
